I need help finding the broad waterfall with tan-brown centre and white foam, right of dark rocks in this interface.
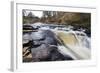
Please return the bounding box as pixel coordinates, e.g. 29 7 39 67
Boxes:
55 31 91 60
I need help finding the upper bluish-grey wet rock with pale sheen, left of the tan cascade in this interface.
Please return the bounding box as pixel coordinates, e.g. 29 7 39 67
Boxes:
30 30 57 45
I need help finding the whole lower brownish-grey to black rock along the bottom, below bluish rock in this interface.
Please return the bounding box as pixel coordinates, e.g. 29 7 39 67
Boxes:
31 44 73 62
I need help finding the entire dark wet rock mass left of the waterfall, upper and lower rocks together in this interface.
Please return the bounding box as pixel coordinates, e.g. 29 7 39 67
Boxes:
23 30 73 62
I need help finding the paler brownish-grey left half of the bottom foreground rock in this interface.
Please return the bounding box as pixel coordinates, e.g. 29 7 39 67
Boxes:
31 44 50 61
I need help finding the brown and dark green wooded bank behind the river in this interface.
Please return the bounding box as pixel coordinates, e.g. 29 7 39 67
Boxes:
23 10 91 34
